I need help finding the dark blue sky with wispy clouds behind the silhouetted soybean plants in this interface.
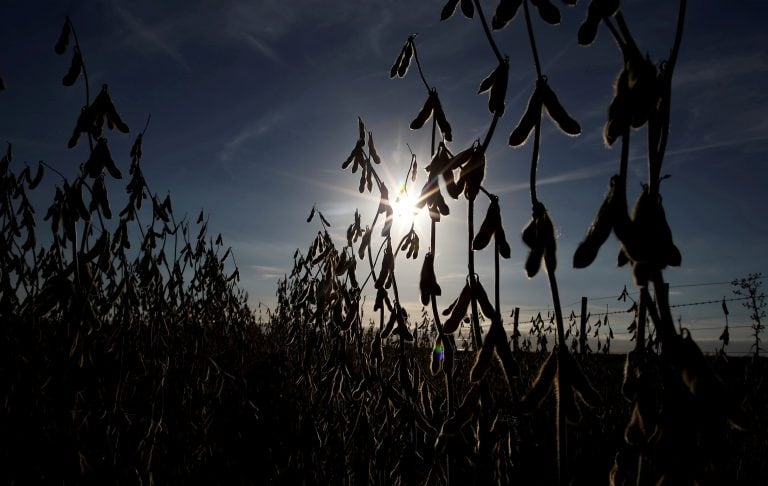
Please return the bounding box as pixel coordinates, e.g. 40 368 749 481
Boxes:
0 0 768 350
